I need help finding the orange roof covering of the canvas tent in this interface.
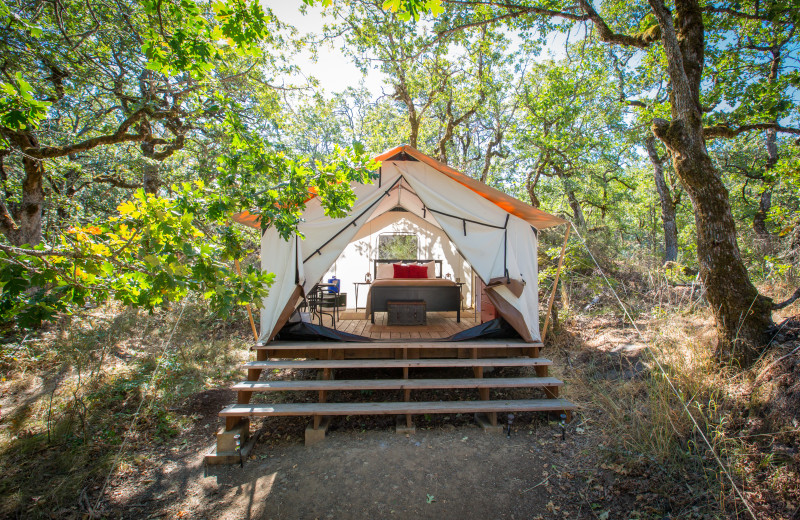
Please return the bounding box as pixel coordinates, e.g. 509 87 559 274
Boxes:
232 144 567 229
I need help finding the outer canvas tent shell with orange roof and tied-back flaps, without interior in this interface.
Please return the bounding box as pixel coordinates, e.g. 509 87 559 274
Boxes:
234 145 566 342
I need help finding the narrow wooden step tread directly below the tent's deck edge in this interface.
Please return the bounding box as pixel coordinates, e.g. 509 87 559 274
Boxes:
243 358 553 370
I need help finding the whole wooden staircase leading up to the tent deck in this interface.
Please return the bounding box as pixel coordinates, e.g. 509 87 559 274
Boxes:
209 340 575 458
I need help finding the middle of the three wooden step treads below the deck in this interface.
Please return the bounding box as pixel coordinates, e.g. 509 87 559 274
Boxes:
233 377 564 392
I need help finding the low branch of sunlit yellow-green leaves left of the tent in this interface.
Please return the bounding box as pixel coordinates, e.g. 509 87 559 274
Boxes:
0 183 274 328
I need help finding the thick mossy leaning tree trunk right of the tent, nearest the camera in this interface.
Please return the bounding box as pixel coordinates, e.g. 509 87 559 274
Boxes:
650 0 773 365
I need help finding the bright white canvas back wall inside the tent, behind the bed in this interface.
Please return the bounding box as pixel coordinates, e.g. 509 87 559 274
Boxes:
322 211 472 308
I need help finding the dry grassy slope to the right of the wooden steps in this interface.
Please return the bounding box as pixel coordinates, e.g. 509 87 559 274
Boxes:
554 300 800 520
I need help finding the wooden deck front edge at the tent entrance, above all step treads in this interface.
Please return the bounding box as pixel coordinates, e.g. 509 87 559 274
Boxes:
252 339 542 350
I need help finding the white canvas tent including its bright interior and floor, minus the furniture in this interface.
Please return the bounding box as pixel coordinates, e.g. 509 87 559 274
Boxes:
234 146 565 342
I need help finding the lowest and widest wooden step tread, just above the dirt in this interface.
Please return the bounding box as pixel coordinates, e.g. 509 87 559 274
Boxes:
219 399 576 417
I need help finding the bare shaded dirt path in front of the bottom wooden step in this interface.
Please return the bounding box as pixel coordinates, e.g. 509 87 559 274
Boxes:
109 418 616 520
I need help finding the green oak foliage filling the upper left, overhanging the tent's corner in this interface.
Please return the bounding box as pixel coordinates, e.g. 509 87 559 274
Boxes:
0 0 375 328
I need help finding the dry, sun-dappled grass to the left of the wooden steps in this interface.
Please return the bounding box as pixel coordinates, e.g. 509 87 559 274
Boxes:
0 305 251 517
